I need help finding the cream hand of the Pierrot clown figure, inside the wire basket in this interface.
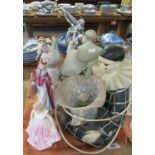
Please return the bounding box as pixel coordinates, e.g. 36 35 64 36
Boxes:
82 130 101 144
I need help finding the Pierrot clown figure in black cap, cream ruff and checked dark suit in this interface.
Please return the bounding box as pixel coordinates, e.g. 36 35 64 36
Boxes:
79 45 132 144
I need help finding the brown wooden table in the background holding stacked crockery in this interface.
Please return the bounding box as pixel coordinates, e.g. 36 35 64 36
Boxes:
23 12 132 39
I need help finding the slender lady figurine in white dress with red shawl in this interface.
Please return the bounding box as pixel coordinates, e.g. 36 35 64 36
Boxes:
31 59 54 111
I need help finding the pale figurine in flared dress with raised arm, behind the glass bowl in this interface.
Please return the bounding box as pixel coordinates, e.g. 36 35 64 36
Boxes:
61 41 86 76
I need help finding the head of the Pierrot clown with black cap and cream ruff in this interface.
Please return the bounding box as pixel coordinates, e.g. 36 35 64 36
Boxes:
92 45 132 91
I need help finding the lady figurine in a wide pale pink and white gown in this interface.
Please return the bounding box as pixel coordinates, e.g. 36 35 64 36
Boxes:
26 103 61 150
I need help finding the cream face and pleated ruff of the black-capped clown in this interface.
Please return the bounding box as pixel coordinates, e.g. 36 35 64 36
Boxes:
92 57 132 91
